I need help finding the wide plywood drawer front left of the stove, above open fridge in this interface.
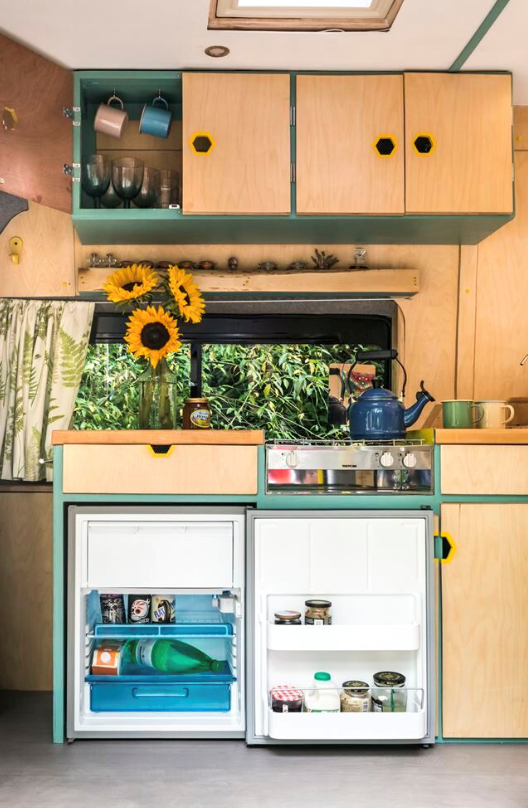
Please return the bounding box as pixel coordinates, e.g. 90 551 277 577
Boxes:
63 444 258 494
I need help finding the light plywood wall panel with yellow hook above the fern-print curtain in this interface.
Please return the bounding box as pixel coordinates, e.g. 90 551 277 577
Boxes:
0 202 76 297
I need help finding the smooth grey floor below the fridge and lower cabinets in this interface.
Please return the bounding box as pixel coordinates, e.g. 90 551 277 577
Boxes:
0 692 528 808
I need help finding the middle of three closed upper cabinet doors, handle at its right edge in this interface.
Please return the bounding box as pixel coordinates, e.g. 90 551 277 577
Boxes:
296 76 404 214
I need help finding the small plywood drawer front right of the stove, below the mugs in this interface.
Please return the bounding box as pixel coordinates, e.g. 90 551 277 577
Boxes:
441 445 528 496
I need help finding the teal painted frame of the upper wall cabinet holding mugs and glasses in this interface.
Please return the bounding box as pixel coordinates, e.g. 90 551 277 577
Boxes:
72 70 514 244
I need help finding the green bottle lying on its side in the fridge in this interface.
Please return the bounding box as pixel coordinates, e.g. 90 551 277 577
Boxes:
123 639 224 674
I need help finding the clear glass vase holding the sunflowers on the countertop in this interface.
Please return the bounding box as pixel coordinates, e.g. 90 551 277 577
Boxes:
137 359 177 429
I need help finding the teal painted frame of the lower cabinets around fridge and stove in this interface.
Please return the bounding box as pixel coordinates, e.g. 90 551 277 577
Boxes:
53 446 528 743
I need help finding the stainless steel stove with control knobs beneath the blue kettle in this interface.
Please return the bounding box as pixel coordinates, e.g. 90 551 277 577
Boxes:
266 438 433 495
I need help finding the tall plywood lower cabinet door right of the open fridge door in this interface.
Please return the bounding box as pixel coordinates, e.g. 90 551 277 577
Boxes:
441 504 528 738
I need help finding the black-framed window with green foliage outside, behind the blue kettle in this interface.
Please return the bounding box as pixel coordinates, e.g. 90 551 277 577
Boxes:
73 314 391 440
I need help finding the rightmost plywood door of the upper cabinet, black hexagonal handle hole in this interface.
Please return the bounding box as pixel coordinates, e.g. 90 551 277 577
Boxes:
405 73 513 214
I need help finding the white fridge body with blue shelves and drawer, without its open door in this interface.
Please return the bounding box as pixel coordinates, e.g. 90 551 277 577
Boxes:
67 507 245 739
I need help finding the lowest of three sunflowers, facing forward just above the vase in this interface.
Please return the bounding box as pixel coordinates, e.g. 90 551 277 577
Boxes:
125 306 181 367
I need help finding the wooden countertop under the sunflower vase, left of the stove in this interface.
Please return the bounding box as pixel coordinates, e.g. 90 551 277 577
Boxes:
51 429 264 446
